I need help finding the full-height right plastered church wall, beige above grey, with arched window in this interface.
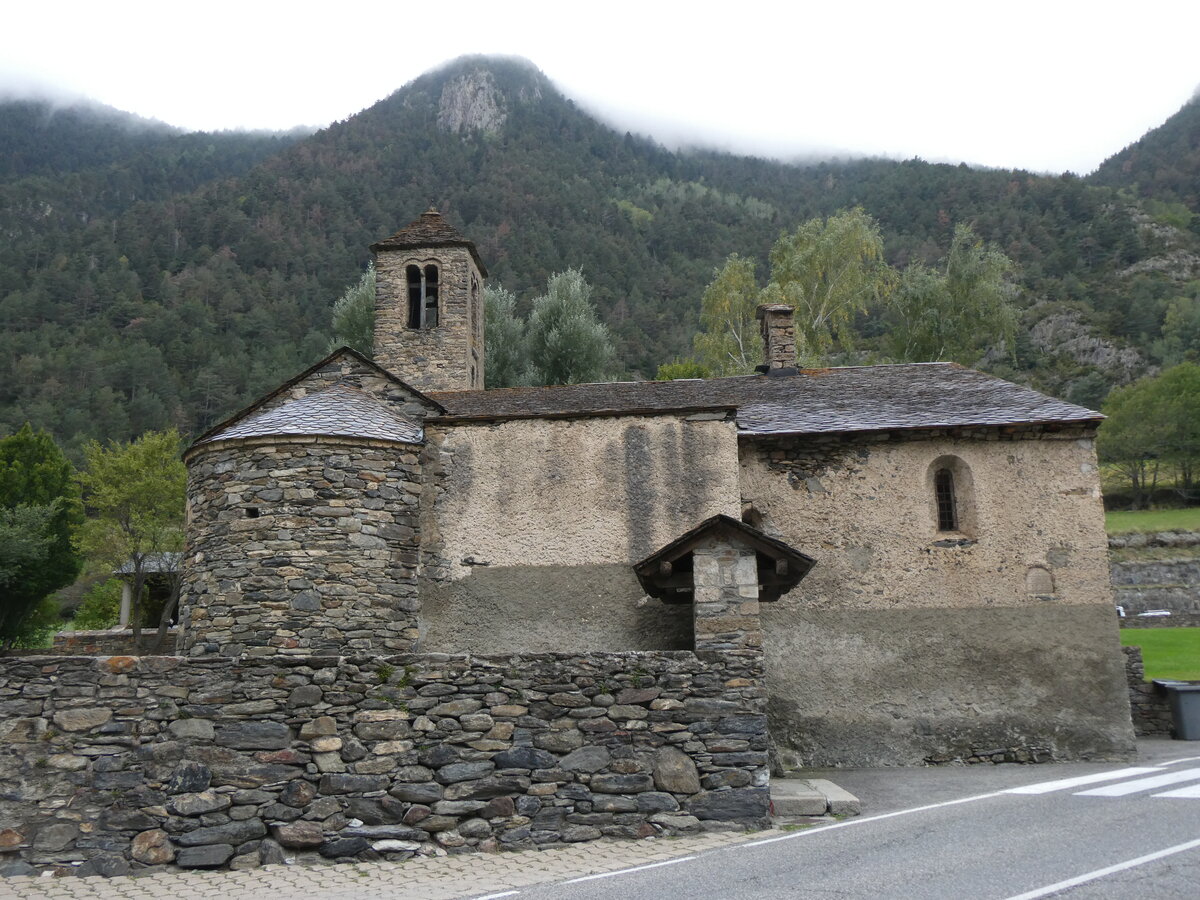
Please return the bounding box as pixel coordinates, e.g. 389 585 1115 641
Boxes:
742 430 1133 766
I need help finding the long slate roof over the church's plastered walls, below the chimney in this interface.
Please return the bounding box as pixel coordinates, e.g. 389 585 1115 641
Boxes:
430 362 1103 434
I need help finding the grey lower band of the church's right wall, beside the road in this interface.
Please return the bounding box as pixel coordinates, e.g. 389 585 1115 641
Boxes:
763 601 1134 767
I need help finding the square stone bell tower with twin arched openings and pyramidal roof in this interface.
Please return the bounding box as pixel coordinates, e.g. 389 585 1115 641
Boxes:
371 208 487 391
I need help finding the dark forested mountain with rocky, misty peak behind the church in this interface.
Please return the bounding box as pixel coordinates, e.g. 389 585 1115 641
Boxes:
0 58 1200 449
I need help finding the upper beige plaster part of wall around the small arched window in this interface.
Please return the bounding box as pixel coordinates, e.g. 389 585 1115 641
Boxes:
742 438 1112 610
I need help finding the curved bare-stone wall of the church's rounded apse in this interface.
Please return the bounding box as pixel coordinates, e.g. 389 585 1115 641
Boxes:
179 438 421 656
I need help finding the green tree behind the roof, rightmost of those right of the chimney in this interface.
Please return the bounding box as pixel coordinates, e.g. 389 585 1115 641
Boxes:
883 224 1018 365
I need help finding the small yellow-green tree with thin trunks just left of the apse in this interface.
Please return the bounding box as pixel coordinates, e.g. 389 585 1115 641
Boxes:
78 430 187 644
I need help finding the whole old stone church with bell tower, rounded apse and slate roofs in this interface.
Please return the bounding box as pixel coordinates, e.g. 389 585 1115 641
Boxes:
179 210 1133 766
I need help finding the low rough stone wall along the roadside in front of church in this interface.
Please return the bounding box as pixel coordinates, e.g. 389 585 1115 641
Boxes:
0 652 768 875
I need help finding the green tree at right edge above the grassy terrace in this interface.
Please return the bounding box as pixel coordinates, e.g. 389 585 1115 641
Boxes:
1096 362 1200 509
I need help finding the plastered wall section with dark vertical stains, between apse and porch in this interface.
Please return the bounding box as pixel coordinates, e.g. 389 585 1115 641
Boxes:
421 415 739 653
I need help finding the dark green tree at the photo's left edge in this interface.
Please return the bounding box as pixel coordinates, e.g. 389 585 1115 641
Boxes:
0 424 82 647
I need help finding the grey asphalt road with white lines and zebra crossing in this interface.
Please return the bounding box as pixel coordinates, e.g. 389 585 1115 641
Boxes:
494 740 1200 900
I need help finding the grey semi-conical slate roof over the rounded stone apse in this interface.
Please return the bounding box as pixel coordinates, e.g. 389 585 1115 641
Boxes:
197 383 424 445
